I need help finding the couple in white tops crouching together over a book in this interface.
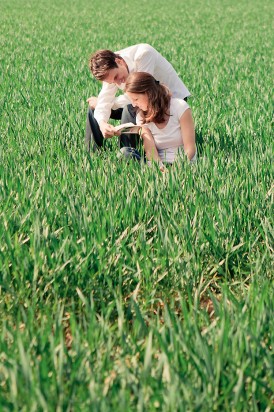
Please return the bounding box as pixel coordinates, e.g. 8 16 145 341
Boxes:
86 44 196 167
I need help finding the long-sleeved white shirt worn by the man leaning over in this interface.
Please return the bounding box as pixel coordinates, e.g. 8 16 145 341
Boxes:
94 44 190 124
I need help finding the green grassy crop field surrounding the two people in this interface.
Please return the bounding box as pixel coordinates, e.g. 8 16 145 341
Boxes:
0 0 274 412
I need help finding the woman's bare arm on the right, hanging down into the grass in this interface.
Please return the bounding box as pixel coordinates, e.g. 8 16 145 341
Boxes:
180 109 196 160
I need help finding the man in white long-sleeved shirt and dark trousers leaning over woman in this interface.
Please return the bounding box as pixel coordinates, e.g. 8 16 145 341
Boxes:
86 44 190 150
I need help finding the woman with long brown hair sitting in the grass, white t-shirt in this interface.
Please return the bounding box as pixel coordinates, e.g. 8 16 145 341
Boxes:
122 72 196 167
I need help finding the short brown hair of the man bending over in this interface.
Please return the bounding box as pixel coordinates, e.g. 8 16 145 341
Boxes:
89 50 122 80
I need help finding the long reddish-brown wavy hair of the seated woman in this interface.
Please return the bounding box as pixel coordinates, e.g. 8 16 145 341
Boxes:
125 72 171 123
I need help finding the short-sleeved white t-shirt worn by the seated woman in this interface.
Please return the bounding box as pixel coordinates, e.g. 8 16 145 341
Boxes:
136 98 192 163
